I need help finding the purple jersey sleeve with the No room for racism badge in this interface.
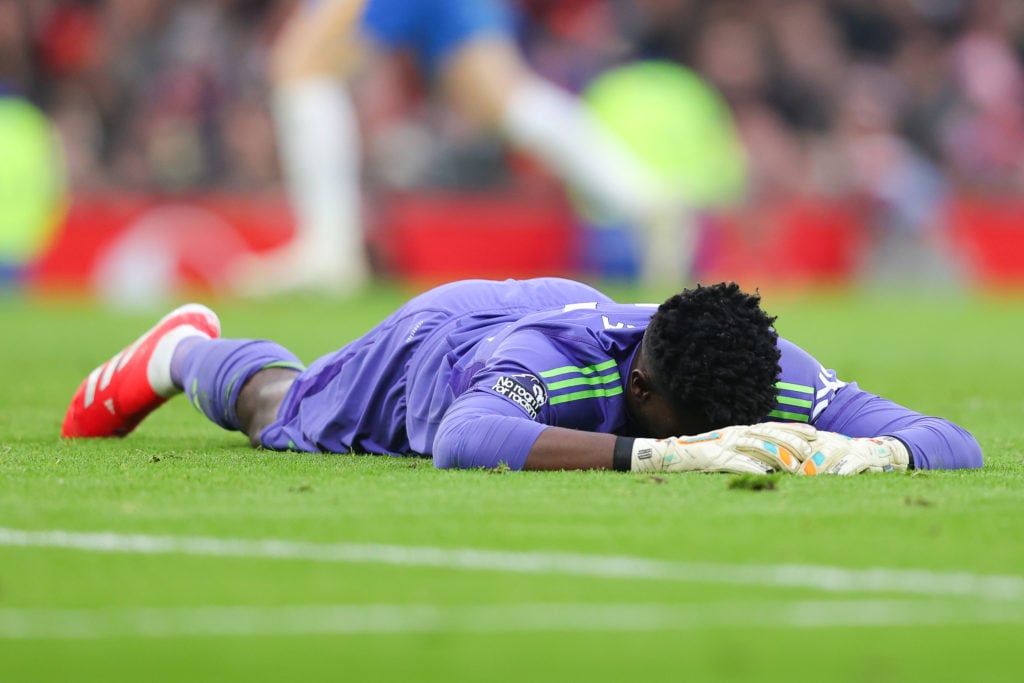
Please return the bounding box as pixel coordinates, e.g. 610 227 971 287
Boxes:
432 332 561 470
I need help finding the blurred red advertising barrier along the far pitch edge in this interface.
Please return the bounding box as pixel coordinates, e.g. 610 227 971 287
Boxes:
30 193 1024 296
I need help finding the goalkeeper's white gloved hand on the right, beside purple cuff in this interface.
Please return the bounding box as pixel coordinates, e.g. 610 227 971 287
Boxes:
797 431 910 475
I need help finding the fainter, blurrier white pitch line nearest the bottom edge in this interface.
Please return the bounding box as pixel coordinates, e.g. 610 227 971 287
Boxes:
0 600 1024 640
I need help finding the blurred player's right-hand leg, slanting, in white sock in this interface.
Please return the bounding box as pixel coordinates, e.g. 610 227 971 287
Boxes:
441 32 692 281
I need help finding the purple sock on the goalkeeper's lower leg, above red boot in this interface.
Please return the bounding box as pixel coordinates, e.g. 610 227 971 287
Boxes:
171 337 305 431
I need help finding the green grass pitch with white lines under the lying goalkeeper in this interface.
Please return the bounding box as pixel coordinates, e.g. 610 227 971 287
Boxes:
0 280 1024 683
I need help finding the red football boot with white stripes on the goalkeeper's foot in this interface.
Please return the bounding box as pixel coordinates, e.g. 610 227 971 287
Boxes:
60 303 220 438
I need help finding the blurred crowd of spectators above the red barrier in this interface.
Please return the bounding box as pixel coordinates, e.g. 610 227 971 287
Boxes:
0 0 1024 225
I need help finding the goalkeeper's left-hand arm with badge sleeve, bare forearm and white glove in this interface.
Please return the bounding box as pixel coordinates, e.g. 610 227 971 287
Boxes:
431 331 813 474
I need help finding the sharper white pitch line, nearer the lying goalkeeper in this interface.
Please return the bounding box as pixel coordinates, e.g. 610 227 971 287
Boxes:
0 527 1024 600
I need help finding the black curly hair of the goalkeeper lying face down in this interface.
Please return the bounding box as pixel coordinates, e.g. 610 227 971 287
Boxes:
643 283 781 431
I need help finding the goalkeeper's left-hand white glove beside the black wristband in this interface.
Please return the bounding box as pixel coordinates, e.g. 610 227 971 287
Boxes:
631 422 817 474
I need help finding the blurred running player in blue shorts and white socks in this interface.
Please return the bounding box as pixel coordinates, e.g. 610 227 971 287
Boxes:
239 0 684 292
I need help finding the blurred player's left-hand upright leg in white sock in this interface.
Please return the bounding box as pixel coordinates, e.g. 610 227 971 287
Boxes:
232 0 370 295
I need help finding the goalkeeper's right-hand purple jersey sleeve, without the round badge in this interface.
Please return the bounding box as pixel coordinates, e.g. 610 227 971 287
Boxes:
769 340 983 469
